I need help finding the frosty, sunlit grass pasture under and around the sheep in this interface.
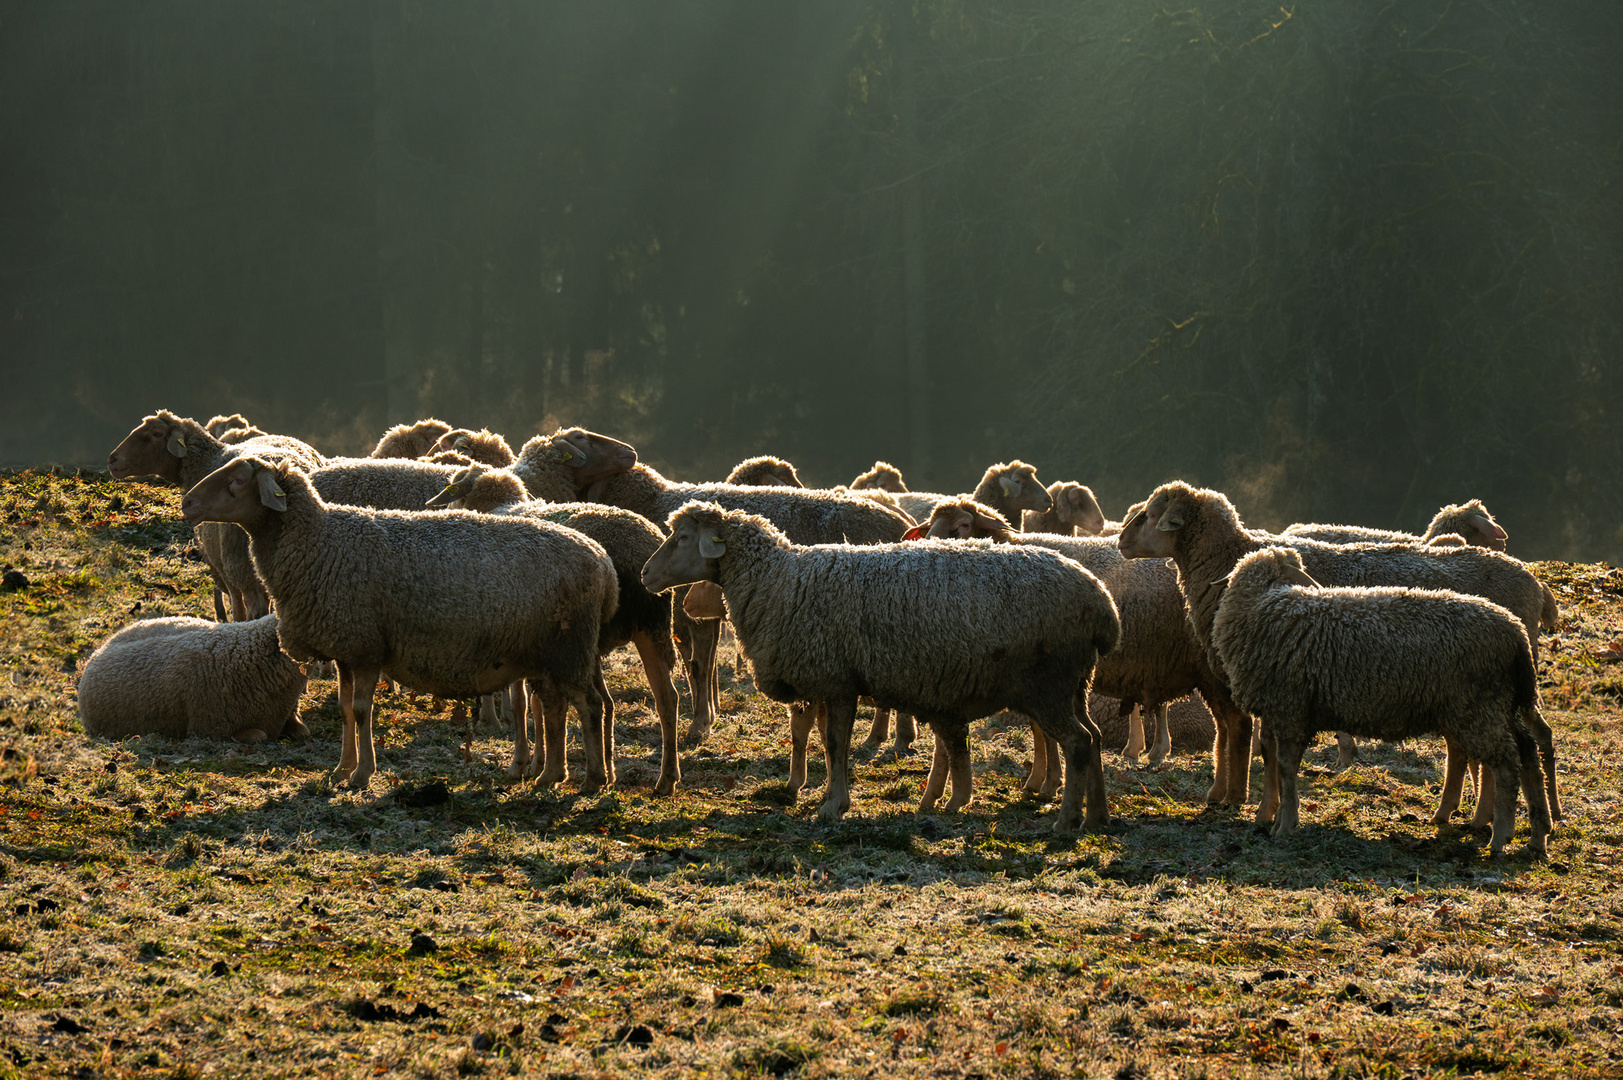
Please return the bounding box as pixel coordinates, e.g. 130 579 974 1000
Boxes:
0 471 1623 1080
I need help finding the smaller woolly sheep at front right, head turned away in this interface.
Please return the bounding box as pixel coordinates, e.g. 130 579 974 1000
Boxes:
1211 547 1550 858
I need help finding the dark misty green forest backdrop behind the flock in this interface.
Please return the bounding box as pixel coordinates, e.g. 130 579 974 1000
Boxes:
0 0 1623 562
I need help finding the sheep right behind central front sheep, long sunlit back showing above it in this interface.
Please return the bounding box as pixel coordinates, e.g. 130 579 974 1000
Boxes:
587 454 912 744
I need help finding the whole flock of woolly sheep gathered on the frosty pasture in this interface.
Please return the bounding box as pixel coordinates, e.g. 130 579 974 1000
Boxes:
78 411 1561 854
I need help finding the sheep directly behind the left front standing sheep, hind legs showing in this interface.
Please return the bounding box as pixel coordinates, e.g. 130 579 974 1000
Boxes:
428 464 682 796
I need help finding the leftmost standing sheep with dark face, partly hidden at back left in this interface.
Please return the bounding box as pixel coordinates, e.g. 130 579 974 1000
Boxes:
107 409 326 622
